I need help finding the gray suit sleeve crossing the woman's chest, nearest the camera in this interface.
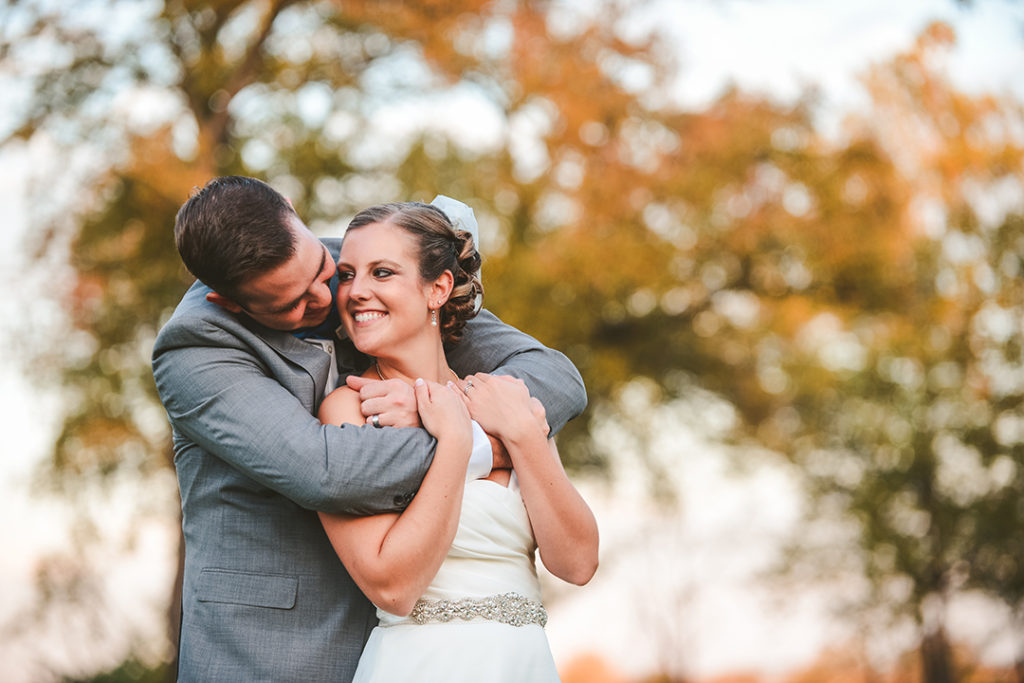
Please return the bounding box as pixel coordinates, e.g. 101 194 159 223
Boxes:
153 322 435 514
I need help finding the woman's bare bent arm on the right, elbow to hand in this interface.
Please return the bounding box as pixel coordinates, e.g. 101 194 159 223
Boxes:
464 374 598 586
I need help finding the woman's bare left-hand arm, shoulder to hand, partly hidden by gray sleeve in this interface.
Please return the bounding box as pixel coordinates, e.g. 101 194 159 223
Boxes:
319 383 473 615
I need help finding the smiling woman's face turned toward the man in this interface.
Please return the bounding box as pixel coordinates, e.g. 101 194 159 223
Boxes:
338 222 444 356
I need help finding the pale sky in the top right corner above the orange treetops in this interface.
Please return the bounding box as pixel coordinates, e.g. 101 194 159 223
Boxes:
658 0 1024 111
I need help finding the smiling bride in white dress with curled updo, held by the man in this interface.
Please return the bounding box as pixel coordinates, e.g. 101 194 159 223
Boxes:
319 203 598 682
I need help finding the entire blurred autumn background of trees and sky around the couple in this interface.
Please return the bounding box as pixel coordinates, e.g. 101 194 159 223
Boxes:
0 0 1024 683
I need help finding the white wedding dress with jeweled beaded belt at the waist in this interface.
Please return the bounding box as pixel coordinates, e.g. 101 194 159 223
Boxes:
353 475 558 683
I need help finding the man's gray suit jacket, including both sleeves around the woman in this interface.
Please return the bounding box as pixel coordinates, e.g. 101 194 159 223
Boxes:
153 240 586 683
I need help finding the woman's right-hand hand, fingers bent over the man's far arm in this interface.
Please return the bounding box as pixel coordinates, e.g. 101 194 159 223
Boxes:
461 373 550 440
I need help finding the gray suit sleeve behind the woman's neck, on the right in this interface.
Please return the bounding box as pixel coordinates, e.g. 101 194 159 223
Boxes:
447 310 587 435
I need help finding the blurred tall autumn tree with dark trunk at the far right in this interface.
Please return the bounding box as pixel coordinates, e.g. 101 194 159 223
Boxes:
774 25 1024 681
